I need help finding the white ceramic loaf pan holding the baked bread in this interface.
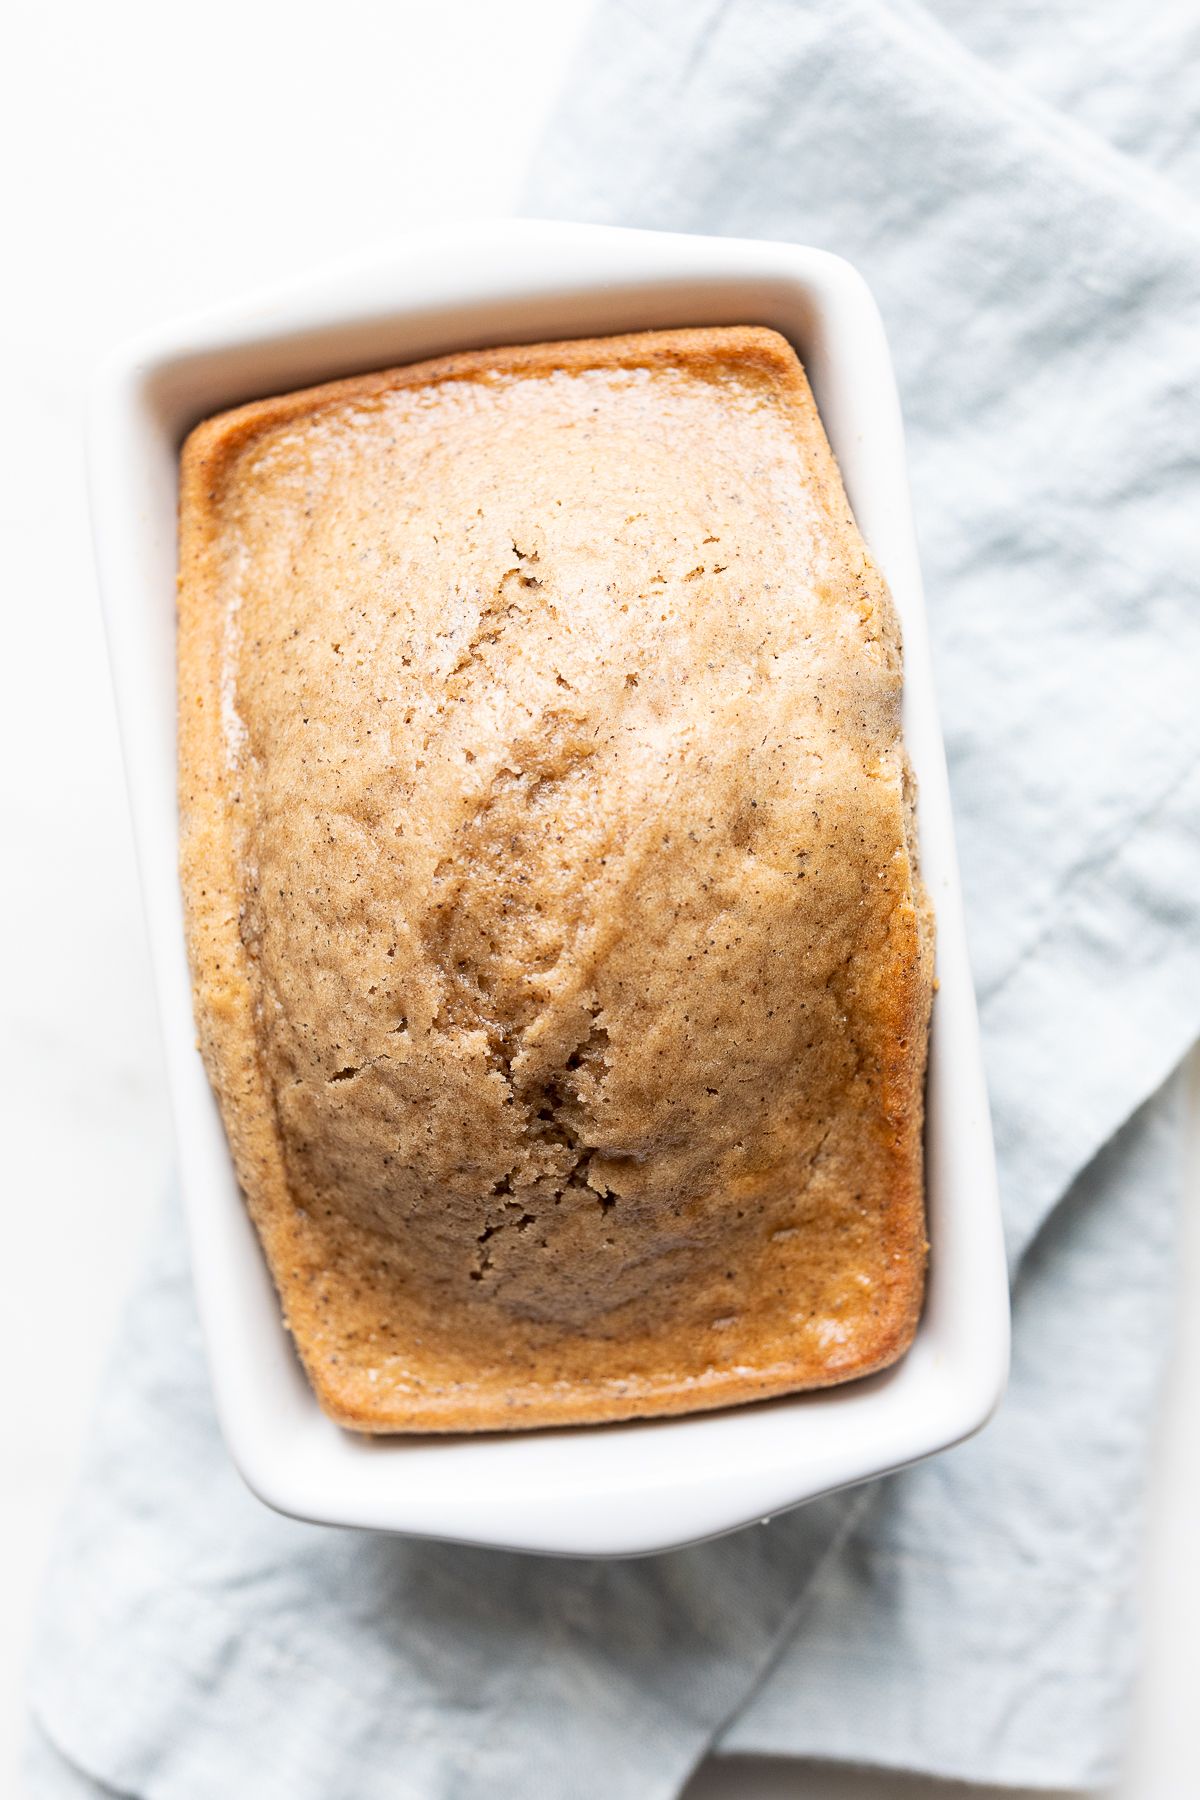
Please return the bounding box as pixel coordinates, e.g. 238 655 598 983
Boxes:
88 221 1009 1555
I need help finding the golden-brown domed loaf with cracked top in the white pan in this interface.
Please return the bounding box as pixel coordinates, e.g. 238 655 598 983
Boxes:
180 329 932 1431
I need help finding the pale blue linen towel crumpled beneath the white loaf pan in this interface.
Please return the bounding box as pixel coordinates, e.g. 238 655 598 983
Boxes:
29 0 1200 1800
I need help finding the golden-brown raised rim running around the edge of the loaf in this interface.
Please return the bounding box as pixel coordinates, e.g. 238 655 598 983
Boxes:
178 326 934 1433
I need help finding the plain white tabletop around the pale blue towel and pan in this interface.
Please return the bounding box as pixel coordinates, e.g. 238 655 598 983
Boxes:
0 0 1200 1800
